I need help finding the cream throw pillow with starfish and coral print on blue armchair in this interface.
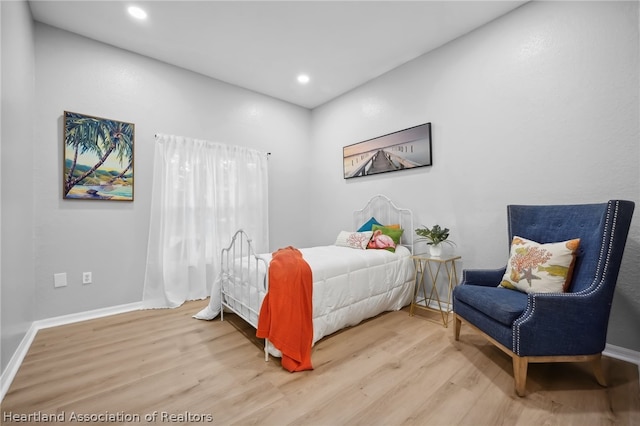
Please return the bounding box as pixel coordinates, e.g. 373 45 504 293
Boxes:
500 236 580 293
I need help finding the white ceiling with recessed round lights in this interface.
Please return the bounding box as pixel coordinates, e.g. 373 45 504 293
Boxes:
29 0 526 108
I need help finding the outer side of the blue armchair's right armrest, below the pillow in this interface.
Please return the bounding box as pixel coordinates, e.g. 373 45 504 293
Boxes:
513 293 611 356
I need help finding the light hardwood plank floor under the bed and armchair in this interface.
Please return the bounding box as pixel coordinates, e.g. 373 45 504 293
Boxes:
0 301 640 426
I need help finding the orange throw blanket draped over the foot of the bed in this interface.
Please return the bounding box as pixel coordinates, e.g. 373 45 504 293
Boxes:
256 247 313 372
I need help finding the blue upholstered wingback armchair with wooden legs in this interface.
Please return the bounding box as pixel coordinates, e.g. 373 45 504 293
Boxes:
452 200 635 396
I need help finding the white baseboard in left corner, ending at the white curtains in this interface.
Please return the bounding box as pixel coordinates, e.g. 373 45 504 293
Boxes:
0 302 142 402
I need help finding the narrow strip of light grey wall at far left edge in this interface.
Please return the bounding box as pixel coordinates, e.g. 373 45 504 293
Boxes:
0 2 35 371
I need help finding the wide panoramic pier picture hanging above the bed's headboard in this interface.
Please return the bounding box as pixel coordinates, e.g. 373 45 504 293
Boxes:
343 123 431 179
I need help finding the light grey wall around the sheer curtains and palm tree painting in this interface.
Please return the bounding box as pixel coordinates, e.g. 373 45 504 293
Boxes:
32 23 310 319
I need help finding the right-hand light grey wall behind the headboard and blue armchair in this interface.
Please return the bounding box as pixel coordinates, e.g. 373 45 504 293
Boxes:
309 2 640 351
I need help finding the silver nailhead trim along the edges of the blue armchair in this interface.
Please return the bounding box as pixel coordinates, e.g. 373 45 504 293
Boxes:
509 201 619 355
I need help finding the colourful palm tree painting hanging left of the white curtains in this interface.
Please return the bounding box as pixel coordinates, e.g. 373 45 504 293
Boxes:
62 111 135 201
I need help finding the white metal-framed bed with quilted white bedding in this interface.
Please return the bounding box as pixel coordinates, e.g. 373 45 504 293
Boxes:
220 195 414 361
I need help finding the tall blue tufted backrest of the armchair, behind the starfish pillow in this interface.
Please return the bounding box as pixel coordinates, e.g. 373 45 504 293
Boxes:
507 200 635 298
